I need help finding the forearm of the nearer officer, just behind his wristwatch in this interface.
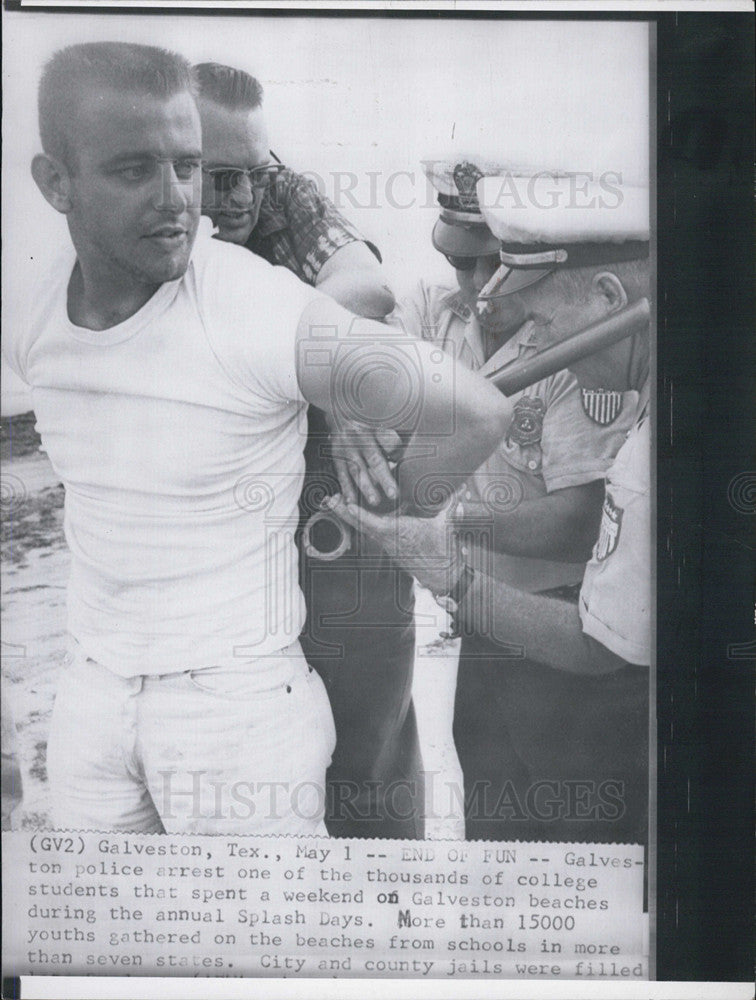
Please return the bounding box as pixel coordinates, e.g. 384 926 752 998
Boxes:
458 573 625 675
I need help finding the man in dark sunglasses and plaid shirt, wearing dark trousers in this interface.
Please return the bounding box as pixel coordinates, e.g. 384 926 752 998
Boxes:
195 63 424 838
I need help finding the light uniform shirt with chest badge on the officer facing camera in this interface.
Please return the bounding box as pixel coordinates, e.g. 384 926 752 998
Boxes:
390 282 638 593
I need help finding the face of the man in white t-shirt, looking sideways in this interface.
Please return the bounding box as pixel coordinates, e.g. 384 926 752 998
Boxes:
68 88 201 291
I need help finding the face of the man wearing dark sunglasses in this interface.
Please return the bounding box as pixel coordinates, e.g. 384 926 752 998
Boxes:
199 100 269 244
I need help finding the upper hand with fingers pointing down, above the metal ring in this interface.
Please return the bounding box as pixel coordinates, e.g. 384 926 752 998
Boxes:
329 421 401 504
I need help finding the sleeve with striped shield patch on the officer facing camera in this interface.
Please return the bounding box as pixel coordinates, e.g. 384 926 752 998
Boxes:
541 371 638 493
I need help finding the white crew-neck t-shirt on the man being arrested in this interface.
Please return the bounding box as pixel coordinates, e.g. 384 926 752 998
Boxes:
7 231 318 676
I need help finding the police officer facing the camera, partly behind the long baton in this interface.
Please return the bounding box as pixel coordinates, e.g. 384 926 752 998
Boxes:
392 159 637 840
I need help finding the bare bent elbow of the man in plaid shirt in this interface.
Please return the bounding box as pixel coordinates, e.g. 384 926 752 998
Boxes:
315 241 395 319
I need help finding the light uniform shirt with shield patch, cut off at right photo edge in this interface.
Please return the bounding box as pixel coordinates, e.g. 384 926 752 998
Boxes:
580 418 651 664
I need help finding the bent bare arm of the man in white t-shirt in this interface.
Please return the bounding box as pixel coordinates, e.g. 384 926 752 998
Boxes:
297 299 512 509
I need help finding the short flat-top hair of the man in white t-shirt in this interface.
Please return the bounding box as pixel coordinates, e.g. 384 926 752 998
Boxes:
38 42 197 168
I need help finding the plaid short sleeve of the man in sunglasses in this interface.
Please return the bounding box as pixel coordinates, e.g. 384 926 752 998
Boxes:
275 172 381 284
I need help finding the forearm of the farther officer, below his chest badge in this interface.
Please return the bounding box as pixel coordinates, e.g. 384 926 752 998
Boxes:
462 480 604 562
